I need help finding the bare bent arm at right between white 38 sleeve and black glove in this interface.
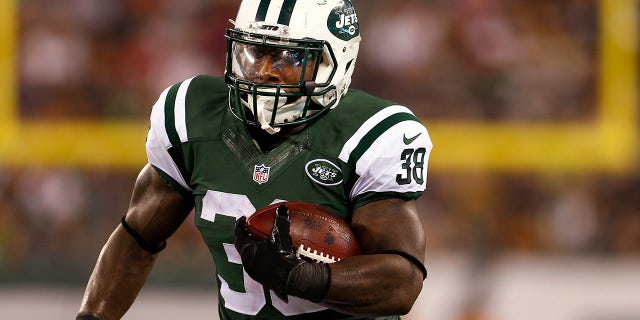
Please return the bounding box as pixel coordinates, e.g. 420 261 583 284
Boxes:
322 198 425 316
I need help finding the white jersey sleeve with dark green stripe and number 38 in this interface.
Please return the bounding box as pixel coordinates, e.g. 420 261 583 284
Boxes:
340 105 433 203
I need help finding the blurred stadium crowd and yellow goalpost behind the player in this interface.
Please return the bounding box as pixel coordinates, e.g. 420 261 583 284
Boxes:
0 0 640 320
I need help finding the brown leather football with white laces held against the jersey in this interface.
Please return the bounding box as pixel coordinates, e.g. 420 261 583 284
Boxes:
247 201 360 263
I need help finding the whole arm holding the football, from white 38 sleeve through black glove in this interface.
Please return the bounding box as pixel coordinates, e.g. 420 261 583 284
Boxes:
234 106 432 317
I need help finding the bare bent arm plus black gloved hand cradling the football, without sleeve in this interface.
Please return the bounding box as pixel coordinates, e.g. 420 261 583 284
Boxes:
234 198 426 317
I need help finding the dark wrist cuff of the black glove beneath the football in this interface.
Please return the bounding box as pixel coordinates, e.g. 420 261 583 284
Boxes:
287 262 331 302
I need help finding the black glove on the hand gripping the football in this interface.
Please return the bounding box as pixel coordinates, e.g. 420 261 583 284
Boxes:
234 205 330 302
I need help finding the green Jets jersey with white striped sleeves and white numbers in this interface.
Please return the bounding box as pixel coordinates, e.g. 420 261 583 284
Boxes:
146 76 432 320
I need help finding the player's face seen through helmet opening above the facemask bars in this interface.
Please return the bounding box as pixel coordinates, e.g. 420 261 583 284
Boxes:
233 43 318 84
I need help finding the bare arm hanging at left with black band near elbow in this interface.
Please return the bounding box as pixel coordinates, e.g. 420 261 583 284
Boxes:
79 165 193 320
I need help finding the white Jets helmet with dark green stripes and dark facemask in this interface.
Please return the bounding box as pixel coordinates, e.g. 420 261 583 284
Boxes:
225 0 360 134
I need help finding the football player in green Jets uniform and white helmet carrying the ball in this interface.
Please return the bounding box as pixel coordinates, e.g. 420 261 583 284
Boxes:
77 0 432 320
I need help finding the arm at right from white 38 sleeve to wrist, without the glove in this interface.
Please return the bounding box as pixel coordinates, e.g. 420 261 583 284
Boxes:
323 106 433 316
